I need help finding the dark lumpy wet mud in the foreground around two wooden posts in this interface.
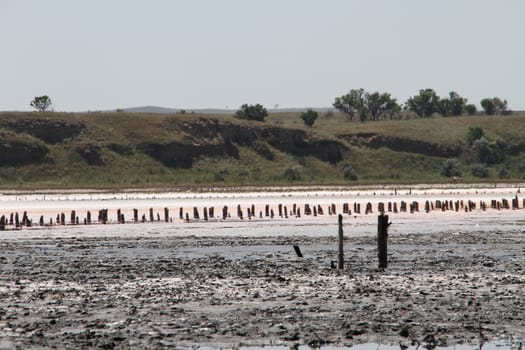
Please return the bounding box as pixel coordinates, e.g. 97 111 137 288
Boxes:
0 232 525 349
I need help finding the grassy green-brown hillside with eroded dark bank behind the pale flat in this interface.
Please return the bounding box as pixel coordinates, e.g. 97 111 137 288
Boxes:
0 112 525 189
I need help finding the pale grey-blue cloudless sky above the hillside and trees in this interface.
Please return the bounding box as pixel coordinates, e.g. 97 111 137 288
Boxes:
0 0 525 112
